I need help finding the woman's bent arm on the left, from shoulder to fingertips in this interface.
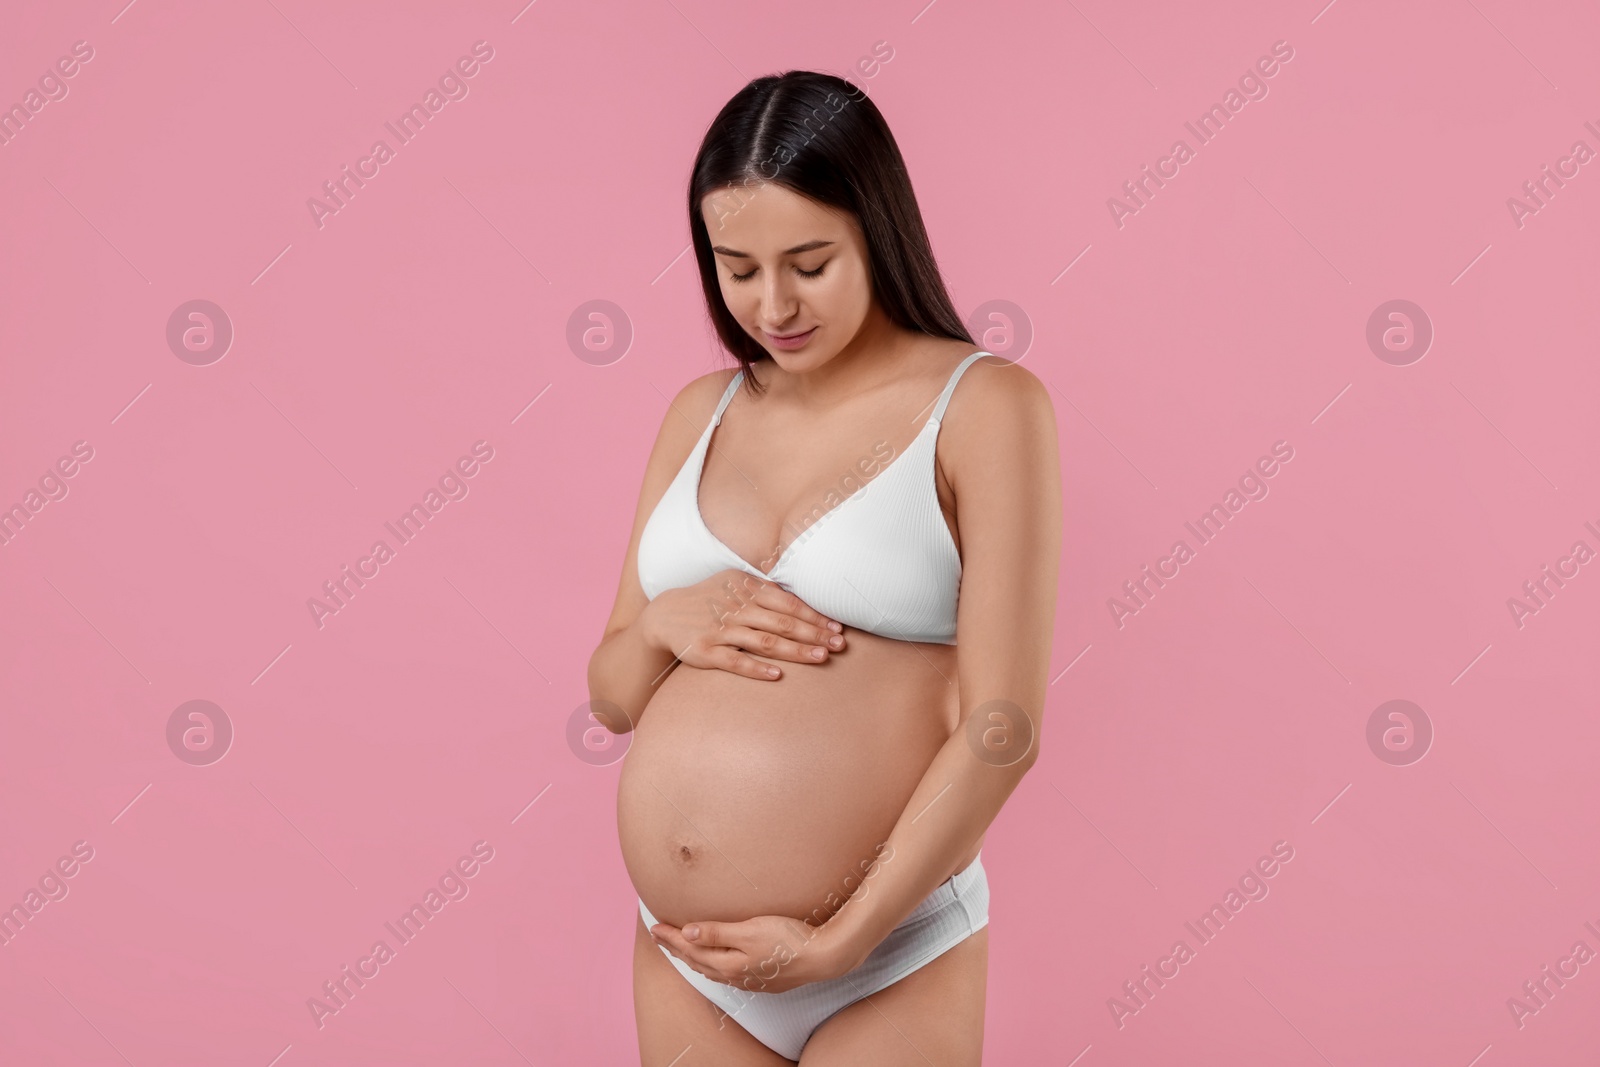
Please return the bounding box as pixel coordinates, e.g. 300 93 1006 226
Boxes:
589 371 843 734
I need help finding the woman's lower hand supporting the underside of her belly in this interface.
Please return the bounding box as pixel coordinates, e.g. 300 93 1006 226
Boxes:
650 915 858 993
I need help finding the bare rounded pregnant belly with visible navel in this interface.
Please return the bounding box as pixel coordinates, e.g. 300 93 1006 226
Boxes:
618 627 976 926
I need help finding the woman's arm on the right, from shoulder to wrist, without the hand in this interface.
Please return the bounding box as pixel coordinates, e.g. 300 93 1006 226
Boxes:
818 358 1062 974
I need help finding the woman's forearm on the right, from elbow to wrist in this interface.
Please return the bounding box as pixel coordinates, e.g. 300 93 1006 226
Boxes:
824 705 1038 966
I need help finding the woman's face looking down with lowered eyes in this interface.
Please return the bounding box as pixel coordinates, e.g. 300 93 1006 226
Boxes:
701 182 872 373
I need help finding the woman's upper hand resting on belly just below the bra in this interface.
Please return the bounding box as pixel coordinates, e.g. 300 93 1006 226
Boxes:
640 568 845 681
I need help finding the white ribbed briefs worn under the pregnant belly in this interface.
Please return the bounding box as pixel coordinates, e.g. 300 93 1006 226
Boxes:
638 853 989 1059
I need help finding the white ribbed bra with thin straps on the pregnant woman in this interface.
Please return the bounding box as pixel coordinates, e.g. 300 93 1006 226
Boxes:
637 352 990 645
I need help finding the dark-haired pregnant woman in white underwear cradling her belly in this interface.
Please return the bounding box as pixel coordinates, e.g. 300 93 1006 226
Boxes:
589 70 1061 1067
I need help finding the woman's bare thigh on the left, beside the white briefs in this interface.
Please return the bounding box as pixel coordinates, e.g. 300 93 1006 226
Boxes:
634 912 794 1067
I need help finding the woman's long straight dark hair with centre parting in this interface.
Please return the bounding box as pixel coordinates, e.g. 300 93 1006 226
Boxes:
690 70 974 394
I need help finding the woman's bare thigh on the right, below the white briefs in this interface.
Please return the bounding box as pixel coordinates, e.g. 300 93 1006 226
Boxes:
800 926 989 1067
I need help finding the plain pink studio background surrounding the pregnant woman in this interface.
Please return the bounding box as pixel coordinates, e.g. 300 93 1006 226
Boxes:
0 0 1600 1067
